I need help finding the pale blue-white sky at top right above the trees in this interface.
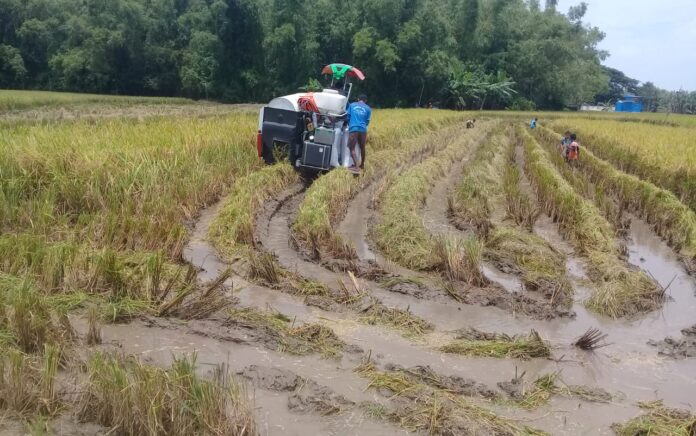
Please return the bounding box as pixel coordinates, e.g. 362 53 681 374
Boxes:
556 0 696 91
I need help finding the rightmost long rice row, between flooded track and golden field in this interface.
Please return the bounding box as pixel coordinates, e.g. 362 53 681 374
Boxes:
538 124 696 271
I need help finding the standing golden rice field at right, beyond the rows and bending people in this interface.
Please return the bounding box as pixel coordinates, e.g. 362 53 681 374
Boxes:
552 118 696 211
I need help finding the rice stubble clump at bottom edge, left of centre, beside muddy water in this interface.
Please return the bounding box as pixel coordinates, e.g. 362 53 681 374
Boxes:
79 353 257 436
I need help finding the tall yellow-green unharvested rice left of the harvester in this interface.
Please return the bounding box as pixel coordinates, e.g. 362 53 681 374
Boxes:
0 114 260 318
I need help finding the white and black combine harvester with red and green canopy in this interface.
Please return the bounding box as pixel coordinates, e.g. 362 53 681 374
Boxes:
256 64 365 176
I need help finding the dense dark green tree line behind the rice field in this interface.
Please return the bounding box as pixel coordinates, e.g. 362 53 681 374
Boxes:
0 0 656 109
